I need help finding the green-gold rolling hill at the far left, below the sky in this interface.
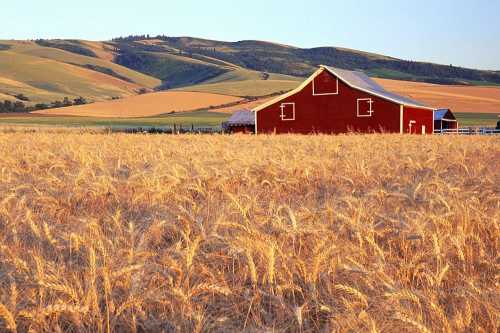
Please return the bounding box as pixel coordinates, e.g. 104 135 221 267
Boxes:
0 41 160 104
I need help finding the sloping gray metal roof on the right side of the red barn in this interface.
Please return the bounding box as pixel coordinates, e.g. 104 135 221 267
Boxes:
322 66 425 107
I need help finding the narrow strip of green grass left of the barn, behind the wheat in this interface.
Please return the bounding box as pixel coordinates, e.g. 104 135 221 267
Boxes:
0 111 230 128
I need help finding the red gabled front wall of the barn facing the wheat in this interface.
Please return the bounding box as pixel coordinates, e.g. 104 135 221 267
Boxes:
256 71 400 134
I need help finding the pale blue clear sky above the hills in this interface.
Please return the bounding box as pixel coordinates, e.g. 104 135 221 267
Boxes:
0 0 500 70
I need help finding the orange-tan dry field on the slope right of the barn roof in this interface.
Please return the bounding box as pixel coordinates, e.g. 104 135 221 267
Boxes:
375 79 500 113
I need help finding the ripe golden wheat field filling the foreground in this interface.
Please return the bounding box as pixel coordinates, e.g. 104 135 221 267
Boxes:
0 130 500 332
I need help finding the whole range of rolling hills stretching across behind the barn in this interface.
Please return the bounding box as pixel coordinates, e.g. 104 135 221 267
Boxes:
0 36 500 118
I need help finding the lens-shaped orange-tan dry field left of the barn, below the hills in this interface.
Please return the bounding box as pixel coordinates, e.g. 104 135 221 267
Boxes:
33 91 241 118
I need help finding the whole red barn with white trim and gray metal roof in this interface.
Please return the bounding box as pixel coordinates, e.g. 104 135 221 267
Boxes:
253 66 444 134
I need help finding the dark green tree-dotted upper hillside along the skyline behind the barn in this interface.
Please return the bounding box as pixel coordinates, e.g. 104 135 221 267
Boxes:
113 36 500 85
